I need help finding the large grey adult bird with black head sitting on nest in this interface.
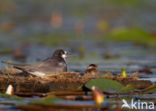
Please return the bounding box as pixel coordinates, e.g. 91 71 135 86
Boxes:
0 49 70 77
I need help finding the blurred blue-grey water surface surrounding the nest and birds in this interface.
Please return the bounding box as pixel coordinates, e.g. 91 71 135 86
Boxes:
0 0 156 111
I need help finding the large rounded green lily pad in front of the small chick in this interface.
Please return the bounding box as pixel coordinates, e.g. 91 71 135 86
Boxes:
85 78 124 91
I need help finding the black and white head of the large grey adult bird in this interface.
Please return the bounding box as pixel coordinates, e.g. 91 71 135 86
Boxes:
53 49 69 58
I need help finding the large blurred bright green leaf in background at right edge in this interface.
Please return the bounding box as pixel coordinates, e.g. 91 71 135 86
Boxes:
107 27 156 46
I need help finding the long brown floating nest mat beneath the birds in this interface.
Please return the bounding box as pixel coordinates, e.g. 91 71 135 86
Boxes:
0 68 151 92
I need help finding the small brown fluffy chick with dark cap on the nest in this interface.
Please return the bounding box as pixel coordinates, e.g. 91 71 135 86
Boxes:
84 64 98 77
